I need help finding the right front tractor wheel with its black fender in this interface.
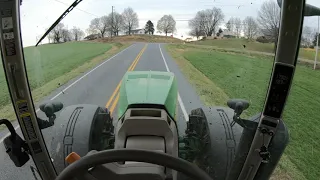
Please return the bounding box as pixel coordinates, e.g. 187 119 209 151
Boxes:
179 107 242 180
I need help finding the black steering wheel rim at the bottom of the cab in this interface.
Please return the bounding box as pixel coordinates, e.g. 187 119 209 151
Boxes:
56 149 212 180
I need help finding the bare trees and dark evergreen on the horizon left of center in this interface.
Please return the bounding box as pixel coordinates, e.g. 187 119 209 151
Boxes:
48 7 176 43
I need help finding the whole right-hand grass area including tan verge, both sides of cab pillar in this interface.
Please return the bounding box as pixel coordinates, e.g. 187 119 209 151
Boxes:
167 45 320 180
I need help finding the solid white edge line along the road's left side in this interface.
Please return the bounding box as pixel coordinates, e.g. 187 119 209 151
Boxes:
0 45 134 143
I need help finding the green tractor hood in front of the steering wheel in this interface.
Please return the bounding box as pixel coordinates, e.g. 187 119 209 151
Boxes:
118 71 178 118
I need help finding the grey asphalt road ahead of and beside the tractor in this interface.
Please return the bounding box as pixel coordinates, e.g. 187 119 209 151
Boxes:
0 43 202 180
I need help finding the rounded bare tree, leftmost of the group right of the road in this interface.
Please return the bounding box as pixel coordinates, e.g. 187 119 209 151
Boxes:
194 7 224 36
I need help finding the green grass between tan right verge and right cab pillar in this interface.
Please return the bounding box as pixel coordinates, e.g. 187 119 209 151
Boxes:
183 51 272 115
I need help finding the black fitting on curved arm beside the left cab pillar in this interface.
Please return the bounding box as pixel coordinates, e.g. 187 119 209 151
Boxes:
0 119 30 167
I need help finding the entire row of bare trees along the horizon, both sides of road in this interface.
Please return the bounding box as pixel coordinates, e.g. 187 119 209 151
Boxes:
49 0 316 45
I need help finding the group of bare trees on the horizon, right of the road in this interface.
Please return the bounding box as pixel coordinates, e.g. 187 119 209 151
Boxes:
189 1 280 41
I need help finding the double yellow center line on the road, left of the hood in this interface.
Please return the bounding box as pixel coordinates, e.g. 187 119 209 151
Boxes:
105 44 147 114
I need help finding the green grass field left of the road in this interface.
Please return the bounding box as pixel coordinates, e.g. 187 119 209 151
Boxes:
0 42 112 107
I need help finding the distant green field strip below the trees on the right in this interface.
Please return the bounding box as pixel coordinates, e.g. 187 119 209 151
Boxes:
192 39 320 61
